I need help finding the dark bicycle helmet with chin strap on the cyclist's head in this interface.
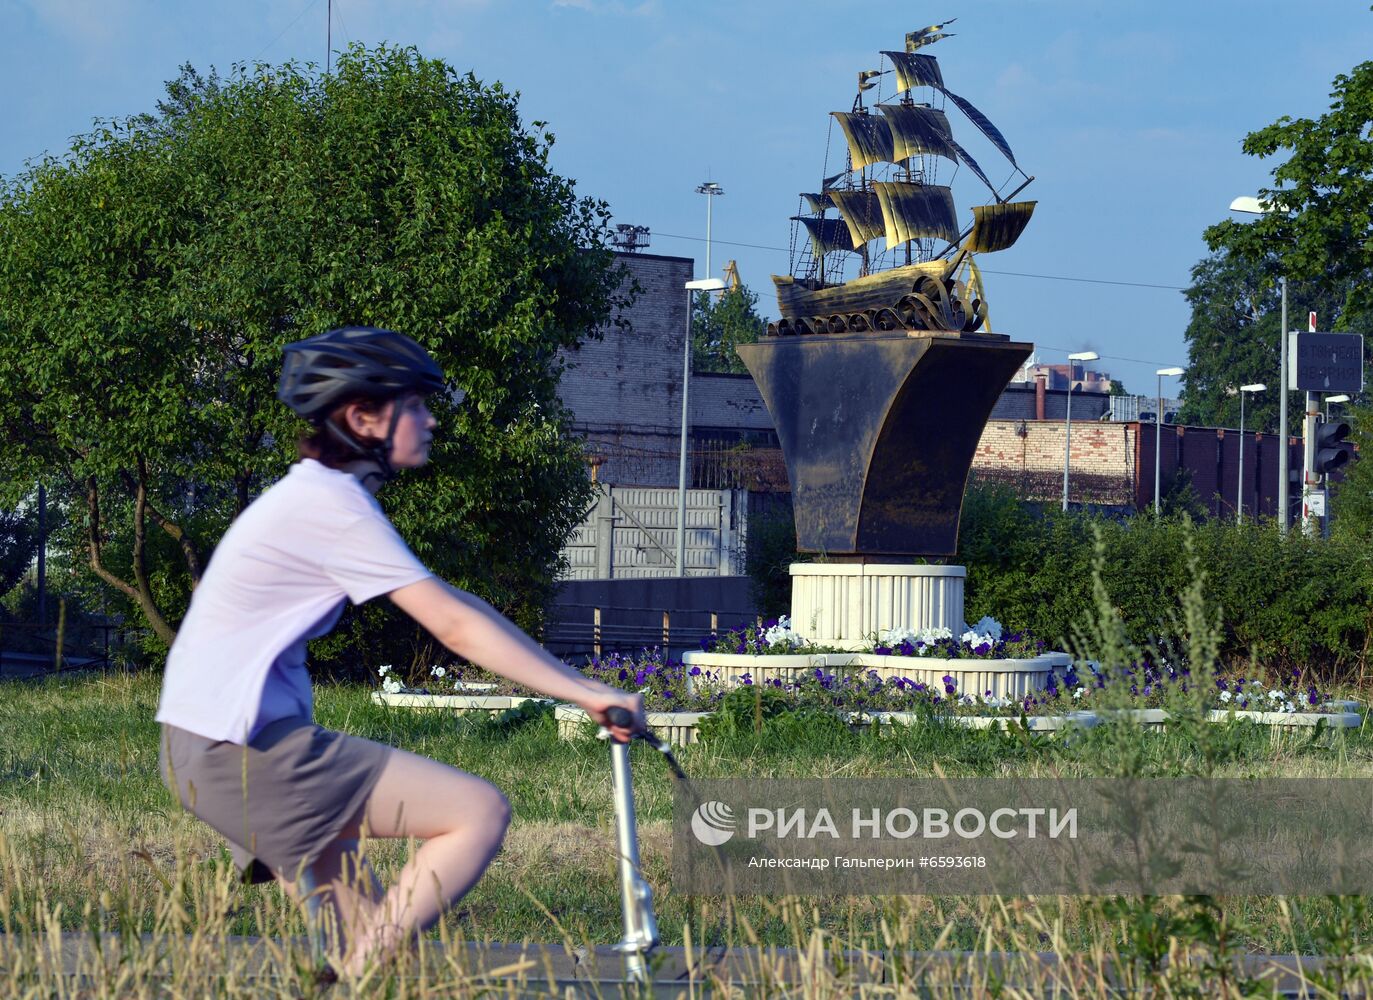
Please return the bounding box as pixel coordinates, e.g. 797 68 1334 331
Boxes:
276 327 443 481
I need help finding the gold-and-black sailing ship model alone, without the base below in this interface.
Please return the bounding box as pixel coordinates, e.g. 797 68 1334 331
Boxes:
768 21 1035 337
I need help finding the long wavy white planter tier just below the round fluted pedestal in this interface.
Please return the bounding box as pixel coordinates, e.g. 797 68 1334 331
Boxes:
682 652 1071 698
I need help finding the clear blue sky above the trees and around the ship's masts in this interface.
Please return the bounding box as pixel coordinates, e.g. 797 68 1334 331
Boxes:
8 0 1373 393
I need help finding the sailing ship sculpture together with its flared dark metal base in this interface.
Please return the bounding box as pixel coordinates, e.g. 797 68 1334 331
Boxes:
737 25 1034 557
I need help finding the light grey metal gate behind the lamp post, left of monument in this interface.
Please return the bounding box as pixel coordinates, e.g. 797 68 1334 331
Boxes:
563 484 748 580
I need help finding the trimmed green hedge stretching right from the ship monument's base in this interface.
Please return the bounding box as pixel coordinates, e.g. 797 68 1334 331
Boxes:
957 485 1373 679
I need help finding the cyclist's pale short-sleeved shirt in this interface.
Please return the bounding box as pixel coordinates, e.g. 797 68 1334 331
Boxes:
157 459 432 743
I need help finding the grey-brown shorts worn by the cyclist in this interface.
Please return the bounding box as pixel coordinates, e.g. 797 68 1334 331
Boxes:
161 718 390 882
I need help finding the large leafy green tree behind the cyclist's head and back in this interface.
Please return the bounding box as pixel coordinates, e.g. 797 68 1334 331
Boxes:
0 47 619 656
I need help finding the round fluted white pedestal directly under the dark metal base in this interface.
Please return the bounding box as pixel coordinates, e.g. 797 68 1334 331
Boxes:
791 563 968 650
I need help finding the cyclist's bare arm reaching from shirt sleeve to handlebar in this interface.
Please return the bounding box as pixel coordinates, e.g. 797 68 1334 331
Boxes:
389 577 644 740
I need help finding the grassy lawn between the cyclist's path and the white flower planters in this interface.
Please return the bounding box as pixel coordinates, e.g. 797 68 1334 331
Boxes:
8 664 1373 992
